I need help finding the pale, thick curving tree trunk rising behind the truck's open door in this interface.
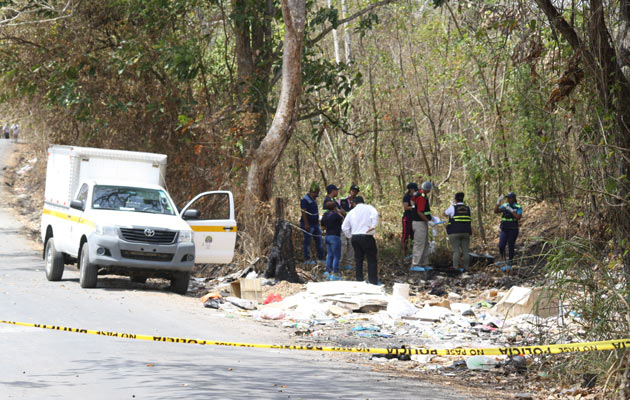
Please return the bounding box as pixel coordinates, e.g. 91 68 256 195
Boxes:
247 0 306 201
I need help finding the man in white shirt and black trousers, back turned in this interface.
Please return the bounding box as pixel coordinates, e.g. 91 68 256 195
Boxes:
341 196 378 285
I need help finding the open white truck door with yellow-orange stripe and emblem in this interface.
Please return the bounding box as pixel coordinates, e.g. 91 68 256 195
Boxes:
181 190 236 264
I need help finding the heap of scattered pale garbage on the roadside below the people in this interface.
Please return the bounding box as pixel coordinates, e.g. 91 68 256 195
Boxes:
203 279 566 365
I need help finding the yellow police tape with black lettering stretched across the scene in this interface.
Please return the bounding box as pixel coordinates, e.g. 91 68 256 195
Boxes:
0 320 630 356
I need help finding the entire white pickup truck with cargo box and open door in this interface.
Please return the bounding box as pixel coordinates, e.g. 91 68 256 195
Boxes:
41 145 237 294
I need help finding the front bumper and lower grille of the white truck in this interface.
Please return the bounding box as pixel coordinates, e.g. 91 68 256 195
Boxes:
88 234 195 272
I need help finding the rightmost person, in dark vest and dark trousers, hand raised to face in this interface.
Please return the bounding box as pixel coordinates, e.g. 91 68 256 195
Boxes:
494 192 523 271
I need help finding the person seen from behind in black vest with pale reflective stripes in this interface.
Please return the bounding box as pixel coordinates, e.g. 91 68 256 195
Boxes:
444 192 472 272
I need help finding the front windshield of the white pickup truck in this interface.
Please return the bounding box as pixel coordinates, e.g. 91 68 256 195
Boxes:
92 185 175 215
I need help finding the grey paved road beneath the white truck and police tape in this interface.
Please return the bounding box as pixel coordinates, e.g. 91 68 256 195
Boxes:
0 139 463 399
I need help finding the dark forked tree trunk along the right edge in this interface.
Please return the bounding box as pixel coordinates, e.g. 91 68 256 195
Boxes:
536 0 630 281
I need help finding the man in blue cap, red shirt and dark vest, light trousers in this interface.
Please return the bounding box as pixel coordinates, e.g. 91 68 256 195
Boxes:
409 181 433 272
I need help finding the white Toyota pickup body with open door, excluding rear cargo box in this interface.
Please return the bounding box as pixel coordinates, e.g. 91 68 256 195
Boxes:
42 145 236 294
